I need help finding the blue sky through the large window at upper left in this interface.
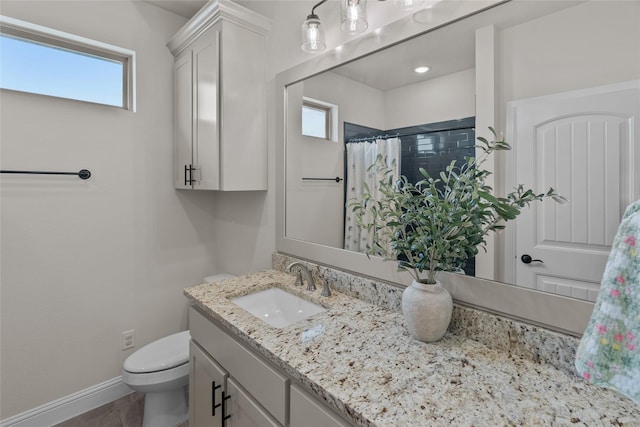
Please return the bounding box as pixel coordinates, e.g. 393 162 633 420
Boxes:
0 34 124 107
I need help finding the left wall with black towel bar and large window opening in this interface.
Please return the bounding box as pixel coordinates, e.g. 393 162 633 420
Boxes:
0 0 218 419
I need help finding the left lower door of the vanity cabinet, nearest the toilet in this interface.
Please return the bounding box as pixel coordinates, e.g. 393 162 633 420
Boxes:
189 341 227 427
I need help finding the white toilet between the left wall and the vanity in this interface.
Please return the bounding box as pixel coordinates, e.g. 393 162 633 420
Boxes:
122 273 234 427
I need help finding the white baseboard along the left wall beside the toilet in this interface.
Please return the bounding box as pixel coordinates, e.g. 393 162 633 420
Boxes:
0 377 133 427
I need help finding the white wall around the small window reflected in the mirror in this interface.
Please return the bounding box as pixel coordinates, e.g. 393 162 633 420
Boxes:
286 72 384 248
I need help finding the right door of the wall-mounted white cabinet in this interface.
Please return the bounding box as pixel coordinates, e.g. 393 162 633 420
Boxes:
192 27 220 190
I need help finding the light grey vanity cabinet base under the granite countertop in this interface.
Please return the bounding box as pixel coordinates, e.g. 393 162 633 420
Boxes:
189 306 350 427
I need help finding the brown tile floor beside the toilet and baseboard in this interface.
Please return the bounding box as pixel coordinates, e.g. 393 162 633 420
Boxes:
54 393 189 427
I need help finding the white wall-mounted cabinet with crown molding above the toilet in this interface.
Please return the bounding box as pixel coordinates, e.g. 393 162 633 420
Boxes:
167 0 270 191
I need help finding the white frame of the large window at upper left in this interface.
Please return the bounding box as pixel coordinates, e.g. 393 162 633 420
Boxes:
0 15 136 112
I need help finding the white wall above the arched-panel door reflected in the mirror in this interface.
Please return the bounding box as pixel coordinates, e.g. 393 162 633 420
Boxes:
498 0 640 122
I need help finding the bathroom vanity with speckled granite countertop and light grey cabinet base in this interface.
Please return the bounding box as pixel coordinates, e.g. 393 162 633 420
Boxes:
185 266 640 426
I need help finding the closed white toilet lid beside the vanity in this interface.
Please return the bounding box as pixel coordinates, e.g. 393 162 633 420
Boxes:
124 331 191 373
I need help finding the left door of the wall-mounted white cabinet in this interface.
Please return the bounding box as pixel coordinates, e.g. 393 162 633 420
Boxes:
173 51 193 188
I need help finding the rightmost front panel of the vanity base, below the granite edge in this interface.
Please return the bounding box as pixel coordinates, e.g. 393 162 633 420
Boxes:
289 386 350 427
